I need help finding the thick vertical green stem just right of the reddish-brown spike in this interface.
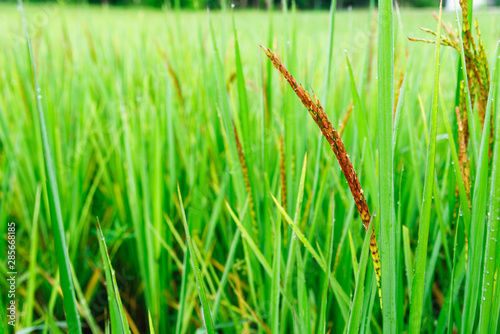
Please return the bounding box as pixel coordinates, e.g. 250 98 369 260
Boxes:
378 0 398 326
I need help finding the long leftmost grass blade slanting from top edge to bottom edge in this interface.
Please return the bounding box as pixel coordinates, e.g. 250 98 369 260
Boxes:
17 0 82 333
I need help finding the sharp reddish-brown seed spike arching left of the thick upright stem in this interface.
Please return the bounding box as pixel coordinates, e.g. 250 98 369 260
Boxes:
260 45 382 307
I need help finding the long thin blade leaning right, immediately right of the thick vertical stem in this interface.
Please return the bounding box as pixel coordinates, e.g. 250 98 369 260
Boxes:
409 1 442 334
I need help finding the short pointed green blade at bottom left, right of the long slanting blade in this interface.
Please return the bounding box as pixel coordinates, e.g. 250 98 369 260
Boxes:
96 219 130 333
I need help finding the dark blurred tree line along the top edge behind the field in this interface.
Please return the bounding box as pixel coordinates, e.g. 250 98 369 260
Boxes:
19 0 450 9
